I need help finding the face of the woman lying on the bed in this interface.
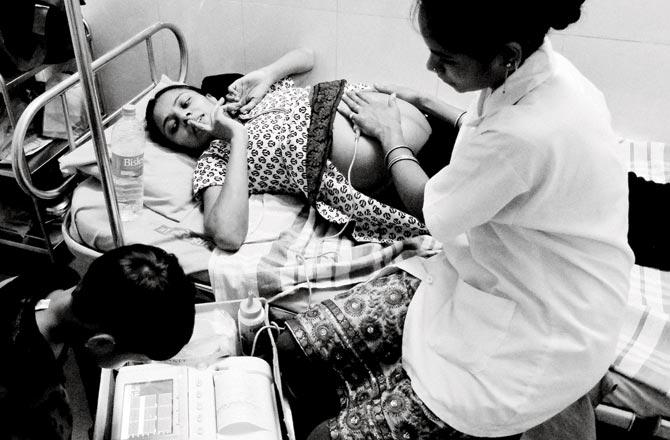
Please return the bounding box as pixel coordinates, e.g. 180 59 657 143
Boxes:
153 88 215 149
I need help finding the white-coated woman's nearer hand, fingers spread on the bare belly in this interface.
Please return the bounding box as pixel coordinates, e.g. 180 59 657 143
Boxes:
338 92 403 146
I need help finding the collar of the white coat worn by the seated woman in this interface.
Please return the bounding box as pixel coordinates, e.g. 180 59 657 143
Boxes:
464 38 555 125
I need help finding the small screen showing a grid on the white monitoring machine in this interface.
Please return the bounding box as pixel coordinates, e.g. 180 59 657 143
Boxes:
121 379 174 440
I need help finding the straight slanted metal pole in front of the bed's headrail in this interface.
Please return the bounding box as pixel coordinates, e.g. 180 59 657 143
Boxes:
65 0 123 247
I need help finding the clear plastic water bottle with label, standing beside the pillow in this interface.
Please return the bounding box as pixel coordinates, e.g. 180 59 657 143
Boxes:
112 105 145 221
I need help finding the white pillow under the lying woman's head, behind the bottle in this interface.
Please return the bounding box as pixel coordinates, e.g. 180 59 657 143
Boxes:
59 75 197 221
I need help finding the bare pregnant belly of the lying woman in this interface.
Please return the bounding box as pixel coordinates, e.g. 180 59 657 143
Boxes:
330 92 431 192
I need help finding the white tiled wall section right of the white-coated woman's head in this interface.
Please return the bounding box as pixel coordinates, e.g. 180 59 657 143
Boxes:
556 0 670 142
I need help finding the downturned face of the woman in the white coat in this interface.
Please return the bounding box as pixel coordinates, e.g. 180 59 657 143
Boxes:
419 19 498 93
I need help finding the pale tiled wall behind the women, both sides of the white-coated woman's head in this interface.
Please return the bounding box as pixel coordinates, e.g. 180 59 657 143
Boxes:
84 0 670 142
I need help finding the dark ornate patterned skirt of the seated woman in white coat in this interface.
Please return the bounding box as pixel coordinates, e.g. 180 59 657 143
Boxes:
287 271 470 440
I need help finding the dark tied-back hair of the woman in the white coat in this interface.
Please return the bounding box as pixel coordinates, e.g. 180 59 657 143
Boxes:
412 0 585 62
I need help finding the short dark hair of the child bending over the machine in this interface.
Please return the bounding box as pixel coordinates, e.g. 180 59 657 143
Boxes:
72 244 195 360
